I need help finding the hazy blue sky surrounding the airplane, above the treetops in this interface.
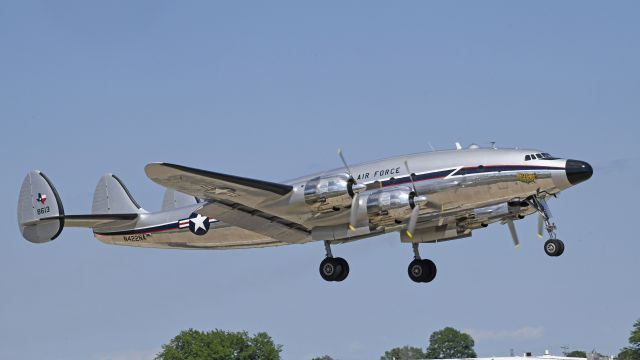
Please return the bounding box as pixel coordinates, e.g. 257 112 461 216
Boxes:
0 1 640 359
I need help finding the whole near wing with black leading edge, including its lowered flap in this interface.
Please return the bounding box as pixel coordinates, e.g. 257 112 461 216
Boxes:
145 163 310 243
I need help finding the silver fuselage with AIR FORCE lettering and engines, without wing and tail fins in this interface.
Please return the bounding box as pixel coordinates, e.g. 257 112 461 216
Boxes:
93 148 592 249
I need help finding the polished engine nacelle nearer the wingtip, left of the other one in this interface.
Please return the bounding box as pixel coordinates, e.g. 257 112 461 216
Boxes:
304 175 366 212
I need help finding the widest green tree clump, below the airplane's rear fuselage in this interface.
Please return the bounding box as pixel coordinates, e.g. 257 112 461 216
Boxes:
156 329 282 360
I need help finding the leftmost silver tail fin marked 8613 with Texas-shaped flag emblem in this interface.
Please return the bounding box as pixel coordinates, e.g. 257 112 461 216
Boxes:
18 170 64 243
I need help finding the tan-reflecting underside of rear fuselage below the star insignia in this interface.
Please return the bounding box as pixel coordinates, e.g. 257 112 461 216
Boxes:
95 226 287 249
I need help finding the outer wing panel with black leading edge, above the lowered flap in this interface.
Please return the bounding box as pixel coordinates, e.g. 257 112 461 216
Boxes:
144 163 293 207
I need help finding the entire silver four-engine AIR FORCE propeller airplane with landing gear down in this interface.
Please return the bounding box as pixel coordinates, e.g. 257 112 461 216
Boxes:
18 143 593 283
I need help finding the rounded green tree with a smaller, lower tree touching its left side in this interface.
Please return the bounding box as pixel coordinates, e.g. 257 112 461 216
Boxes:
425 327 477 359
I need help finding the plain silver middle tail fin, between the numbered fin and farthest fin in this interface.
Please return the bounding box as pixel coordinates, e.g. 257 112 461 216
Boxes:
91 174 146 214
